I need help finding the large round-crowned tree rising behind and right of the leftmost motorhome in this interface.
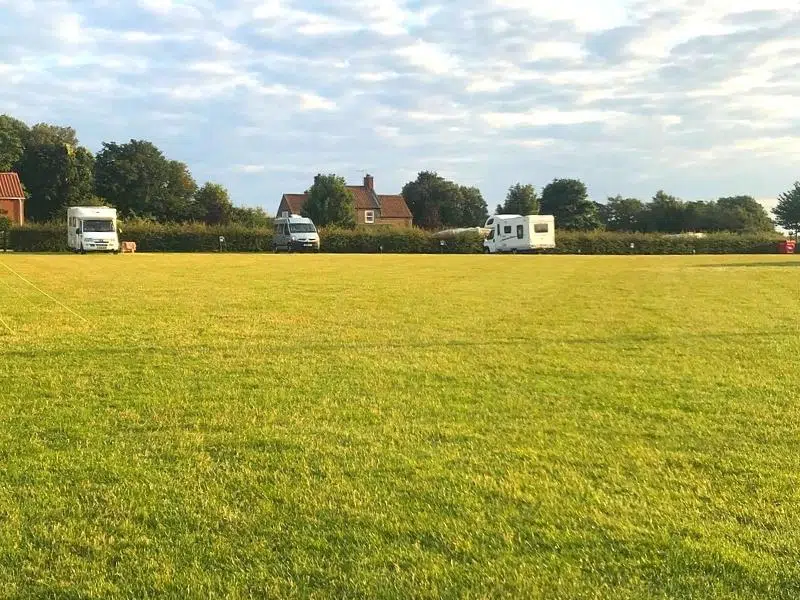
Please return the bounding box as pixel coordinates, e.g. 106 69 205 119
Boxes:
95 140 197 221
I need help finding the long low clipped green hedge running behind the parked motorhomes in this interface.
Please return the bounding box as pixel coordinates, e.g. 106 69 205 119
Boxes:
0 222 784 254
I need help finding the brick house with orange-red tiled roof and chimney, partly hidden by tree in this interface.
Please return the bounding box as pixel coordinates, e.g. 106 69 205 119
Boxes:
278 175 413 227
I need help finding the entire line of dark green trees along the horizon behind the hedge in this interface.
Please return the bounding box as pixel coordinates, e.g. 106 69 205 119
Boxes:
6 115 800 233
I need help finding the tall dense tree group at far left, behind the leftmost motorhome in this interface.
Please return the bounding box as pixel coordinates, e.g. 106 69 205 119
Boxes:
0 115 271 226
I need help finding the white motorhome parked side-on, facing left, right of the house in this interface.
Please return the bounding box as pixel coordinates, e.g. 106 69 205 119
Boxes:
483 215 556 254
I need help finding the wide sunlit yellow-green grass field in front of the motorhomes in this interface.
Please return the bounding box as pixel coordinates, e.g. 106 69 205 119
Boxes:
0 254 800 599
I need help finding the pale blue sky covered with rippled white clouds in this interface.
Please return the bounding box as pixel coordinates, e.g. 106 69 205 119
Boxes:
0 0 800 212
